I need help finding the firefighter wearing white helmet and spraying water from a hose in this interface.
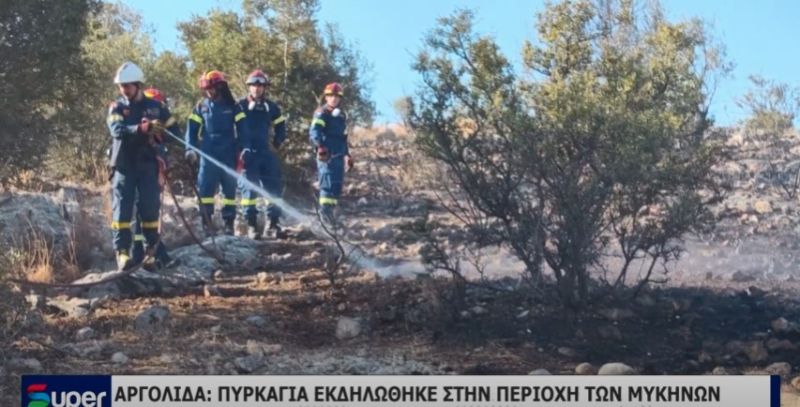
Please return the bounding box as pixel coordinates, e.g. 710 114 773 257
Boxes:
106 62 178 269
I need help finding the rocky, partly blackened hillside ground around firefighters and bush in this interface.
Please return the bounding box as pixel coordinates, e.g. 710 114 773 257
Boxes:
0 126 800 405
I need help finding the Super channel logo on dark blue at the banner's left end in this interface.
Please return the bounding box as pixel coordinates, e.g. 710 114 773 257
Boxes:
20 376 111 407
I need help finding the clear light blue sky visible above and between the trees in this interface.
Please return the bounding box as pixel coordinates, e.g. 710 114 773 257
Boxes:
123 0 800 125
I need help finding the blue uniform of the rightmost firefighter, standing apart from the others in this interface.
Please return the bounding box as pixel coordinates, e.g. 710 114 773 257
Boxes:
309 105 350 209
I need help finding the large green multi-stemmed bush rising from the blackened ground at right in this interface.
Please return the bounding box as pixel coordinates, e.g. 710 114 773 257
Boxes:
406 1 725 307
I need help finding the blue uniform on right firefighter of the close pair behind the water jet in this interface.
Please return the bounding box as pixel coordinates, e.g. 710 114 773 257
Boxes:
239 97 286 224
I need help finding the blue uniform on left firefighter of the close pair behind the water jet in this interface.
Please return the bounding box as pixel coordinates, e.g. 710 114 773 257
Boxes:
186 98 249 225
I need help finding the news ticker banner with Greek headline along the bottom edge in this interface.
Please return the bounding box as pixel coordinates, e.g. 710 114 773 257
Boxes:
21 375 780 407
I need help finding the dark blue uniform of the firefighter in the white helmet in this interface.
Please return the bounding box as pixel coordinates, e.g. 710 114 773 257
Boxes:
106 97 177 252
